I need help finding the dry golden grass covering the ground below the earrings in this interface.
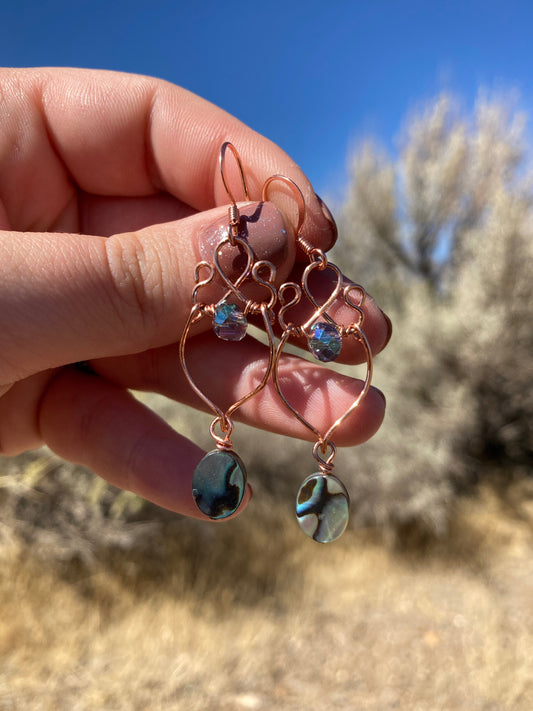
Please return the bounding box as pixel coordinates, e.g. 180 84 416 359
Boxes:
0 484 533 711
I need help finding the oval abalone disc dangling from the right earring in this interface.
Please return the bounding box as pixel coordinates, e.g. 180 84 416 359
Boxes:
296 472 350 543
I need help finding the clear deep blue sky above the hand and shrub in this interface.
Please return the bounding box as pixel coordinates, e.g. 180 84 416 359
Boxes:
0 0 533 199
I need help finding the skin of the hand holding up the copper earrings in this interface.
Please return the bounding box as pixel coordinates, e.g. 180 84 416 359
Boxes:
0 69 390 518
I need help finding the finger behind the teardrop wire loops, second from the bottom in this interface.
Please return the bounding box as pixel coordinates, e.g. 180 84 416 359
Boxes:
91 333 385 446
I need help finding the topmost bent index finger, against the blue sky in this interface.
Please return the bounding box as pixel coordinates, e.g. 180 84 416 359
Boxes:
0 68 335 249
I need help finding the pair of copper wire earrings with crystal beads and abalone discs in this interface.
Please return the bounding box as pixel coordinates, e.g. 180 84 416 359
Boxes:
179 142 372 543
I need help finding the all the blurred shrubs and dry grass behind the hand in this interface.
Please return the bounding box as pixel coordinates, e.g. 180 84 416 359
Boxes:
0 95 533 711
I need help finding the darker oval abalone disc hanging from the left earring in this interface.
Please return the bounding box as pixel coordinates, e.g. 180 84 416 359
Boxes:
192 449 246 519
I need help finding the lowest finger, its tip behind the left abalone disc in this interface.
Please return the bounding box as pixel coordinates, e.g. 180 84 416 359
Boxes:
38 368 251 519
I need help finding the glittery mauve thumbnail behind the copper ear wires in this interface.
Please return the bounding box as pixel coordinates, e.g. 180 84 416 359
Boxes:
198 202 294 278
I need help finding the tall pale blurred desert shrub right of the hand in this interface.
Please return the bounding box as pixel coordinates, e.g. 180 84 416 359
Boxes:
330 96 533 532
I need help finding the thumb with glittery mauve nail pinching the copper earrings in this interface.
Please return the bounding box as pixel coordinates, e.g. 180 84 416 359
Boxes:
0 203 295 385
